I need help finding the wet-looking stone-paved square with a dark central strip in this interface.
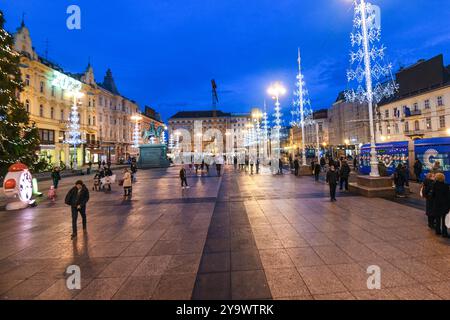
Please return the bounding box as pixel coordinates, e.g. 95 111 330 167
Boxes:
0 167 450 299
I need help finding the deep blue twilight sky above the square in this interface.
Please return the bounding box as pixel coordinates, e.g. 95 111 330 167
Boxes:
0 0 450 120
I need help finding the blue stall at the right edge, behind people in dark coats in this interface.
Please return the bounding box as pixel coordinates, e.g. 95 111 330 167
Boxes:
414 137 450 183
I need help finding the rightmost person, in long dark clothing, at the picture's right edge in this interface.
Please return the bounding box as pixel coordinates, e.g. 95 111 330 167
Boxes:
431 173 450 238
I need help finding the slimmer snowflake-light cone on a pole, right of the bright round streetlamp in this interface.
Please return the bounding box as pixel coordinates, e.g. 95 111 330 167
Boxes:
291 49 314 166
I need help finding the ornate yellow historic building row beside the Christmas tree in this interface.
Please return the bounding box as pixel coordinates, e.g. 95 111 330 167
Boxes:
13 22 160 166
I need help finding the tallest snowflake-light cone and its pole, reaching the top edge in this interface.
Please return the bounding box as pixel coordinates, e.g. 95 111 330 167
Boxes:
345 0 398 177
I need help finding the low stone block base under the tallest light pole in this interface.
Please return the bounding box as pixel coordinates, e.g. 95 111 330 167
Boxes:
349 175 395 198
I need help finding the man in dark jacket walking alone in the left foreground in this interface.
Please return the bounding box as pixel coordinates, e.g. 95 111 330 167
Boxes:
65 180 89 239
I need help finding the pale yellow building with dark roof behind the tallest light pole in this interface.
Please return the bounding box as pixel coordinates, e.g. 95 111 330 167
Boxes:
376 55 450 142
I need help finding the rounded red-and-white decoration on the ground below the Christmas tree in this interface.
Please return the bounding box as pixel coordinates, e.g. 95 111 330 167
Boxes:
3 162 33 210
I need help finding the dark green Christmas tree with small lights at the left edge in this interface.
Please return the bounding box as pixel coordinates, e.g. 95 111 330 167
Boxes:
0 11 42 176
